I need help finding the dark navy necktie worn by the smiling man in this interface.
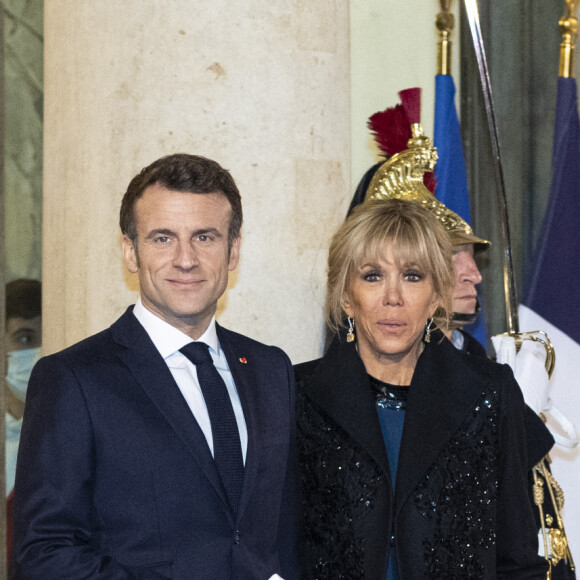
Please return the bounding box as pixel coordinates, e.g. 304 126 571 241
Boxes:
180 342 244 512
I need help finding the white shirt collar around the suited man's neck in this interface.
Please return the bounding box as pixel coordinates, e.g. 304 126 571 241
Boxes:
133 297 220 359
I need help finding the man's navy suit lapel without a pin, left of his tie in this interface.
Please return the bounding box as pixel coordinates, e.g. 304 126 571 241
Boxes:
111 307 230 512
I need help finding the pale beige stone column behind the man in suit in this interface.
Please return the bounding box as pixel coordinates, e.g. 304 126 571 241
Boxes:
43 0 350 362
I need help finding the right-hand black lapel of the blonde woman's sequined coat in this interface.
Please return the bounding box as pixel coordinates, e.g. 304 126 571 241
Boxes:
395 333 488 513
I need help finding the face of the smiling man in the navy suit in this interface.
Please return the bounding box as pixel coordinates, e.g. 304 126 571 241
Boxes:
123 185 240 339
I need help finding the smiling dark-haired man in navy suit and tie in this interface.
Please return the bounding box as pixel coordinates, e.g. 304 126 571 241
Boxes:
14 154 297 580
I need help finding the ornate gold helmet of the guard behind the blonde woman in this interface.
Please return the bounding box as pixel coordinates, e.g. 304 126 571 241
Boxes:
365 123 491 252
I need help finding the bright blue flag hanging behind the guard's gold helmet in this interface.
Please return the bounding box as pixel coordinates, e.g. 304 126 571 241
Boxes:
433 75 487 347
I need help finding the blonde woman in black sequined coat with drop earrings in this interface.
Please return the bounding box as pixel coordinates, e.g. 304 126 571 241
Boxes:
296 200 546 580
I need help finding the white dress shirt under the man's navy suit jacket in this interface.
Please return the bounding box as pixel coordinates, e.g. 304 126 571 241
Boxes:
133 298 248 465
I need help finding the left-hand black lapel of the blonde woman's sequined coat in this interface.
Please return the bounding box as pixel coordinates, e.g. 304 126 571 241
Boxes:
305 337 390 480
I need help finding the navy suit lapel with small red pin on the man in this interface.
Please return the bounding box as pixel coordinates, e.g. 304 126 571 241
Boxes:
216 324 260 520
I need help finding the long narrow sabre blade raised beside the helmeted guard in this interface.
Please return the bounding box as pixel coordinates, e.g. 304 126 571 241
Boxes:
465 0 519 334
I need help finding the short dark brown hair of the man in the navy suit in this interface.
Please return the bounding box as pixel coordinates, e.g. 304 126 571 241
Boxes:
120 153 243 247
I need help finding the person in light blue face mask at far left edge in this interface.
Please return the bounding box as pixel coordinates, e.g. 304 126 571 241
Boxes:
4 279 42 496
